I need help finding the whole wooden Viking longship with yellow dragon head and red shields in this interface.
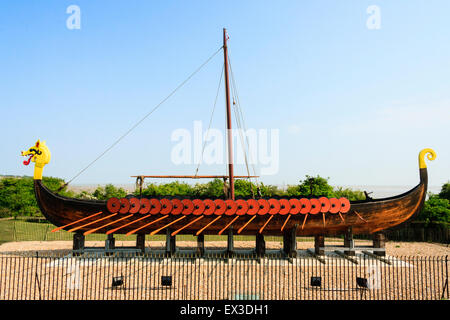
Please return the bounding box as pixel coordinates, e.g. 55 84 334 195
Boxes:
22 29 436 240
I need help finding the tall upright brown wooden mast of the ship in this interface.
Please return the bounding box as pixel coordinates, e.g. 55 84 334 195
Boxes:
223 28 234 200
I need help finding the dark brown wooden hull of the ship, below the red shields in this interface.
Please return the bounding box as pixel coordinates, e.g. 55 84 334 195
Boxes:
34 168 428 236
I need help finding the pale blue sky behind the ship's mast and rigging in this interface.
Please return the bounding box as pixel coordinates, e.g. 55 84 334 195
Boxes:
0 0 450 189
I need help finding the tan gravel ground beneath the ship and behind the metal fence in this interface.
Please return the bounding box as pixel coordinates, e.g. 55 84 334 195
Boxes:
0 241 450 300
